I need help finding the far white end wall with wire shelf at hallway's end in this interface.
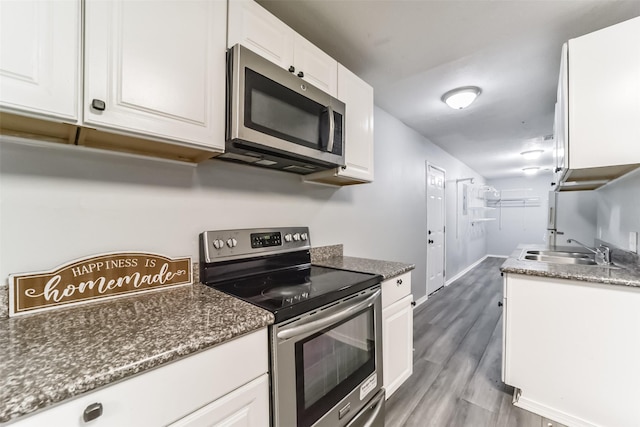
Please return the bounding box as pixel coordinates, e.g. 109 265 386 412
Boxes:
484 173 551 256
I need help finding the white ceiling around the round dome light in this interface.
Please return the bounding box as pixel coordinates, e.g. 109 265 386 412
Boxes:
258 0 640 179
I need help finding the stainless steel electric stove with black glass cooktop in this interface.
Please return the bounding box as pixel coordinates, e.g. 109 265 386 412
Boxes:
200 227 385 427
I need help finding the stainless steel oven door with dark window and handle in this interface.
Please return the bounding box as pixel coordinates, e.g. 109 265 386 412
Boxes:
271 286 382 427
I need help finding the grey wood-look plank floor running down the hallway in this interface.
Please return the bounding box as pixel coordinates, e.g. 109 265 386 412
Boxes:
385 258 564 427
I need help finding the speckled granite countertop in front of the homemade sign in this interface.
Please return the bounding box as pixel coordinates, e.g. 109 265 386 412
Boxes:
0 283 273 422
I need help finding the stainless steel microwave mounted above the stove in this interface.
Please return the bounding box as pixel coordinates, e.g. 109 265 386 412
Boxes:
218 45 345 175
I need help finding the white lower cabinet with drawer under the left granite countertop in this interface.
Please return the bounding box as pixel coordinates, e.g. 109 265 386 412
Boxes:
3 328 269 427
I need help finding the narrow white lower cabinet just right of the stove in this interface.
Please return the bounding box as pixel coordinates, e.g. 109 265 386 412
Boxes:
382 273 413 399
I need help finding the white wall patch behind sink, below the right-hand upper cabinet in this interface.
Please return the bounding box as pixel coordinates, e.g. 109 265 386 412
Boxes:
596 169 640 250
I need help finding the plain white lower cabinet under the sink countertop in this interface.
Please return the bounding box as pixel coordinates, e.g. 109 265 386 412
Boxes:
503 273 640 427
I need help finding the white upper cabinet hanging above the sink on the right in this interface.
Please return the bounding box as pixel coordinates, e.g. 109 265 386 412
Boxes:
556 18 640 188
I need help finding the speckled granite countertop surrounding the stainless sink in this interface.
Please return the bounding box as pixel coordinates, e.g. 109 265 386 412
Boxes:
500 245 640 287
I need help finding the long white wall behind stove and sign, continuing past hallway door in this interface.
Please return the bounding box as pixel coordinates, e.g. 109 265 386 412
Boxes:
0 108 485 299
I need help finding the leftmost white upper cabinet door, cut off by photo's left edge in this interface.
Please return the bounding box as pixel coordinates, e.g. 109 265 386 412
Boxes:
0 0 80 123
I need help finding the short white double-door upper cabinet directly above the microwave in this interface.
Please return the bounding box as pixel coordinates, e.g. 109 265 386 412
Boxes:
227 0 338 97
